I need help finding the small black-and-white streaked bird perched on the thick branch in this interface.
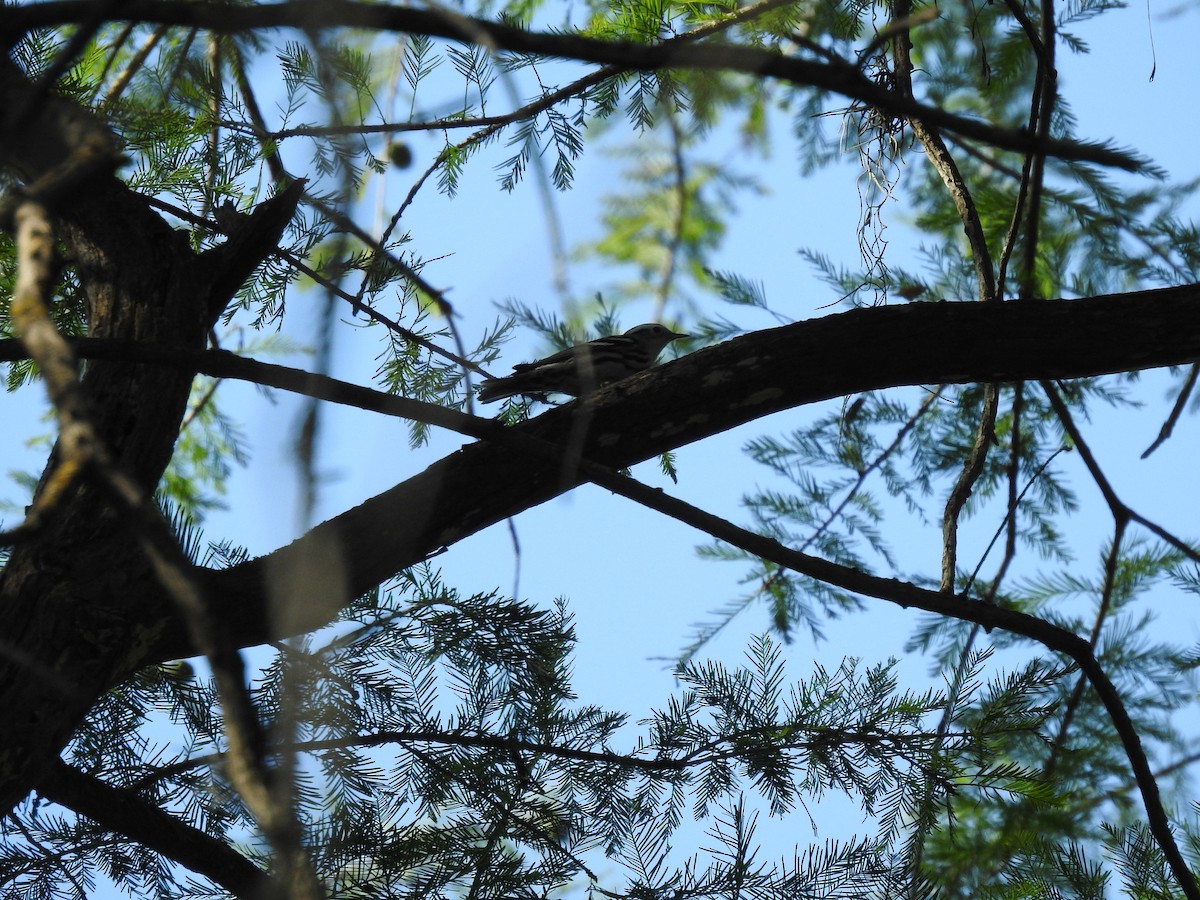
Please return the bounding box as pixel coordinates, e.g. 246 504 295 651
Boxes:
479 323 689 403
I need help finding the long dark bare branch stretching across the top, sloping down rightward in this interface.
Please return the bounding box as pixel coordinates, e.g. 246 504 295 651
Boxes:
2 0 1142 170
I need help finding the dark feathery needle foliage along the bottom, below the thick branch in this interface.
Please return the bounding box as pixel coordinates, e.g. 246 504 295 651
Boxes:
5 600 1075 898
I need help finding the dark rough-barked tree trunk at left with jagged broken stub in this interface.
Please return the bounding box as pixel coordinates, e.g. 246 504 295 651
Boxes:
0 64 300 809
